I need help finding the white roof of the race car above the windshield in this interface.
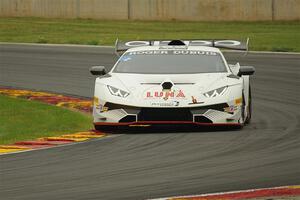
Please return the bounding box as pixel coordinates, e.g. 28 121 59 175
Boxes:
126 45 221 53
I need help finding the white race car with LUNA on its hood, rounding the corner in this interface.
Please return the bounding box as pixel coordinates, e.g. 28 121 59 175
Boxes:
90 40 254 130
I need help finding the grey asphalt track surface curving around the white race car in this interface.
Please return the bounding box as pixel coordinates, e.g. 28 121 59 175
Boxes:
0 45 300 200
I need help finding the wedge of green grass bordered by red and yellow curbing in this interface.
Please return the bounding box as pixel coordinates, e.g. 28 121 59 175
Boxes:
0 95 92 144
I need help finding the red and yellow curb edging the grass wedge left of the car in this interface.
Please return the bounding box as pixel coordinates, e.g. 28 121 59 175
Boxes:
0 87 106 155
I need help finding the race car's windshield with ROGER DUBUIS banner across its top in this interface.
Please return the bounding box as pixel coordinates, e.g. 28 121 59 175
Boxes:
113 50 227 74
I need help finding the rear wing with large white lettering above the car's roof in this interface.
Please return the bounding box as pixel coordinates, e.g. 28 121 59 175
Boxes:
115 38 249 55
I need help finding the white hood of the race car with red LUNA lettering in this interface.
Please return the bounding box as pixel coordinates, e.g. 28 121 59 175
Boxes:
99 73 242 107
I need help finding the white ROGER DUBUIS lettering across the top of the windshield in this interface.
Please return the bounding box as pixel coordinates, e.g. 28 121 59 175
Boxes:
127 50 218 56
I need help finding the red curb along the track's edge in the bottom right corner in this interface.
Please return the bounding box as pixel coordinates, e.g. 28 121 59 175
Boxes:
149 185 300 200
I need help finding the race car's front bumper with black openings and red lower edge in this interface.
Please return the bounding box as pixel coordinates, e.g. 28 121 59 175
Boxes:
93 103 241 126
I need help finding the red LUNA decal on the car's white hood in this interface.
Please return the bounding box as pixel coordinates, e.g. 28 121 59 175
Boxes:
145 90 185 100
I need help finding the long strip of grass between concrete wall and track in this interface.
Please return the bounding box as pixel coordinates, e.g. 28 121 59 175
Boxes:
0 18 300 52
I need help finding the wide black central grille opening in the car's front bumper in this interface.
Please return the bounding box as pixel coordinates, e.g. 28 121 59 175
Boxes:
138 108 193 121
